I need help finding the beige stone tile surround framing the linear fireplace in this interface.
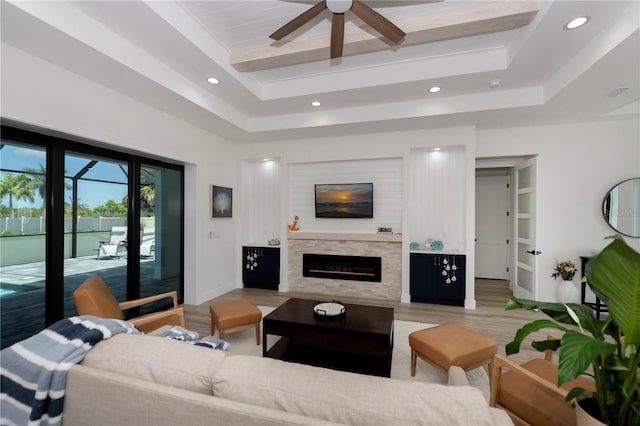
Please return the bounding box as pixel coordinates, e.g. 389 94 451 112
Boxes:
288 232 402 301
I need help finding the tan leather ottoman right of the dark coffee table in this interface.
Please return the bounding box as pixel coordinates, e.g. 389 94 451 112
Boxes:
409 323 498 376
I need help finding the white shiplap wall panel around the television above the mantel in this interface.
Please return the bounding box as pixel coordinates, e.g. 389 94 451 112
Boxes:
289 158 402 233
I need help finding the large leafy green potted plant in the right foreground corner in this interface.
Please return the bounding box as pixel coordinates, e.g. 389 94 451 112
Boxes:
506 236 640 425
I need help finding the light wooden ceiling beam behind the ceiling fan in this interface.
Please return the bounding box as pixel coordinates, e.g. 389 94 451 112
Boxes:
230 0 539 72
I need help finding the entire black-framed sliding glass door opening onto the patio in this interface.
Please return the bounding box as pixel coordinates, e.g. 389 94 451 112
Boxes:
0 126 184 348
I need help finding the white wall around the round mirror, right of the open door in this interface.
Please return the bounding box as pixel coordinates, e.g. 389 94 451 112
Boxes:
476 120 640 301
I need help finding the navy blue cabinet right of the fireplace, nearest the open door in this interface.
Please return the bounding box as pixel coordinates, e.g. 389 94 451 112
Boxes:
409 253 466 306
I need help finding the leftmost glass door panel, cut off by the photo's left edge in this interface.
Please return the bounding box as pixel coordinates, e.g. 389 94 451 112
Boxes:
0 139 47 349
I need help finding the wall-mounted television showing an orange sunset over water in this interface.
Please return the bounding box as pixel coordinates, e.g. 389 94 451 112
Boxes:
315 183 373 219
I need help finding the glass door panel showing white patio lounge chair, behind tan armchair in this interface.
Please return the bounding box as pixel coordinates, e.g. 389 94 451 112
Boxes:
64 152 129 317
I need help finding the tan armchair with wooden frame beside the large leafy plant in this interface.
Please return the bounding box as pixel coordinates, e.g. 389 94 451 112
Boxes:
489 336 595 426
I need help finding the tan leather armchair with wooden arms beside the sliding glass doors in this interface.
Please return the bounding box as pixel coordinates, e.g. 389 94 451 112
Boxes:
73 275 189 333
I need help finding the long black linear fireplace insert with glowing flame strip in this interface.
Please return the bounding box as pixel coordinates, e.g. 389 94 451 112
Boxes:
302 254 382 282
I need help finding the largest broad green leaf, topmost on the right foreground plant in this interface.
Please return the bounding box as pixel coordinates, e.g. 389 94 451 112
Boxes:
586 237 640 346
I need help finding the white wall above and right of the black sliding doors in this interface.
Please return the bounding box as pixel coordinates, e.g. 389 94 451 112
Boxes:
0 43 239 303
